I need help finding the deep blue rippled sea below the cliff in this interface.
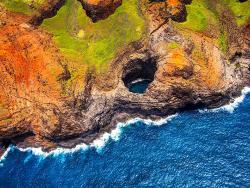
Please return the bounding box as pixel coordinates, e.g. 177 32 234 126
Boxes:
0 89 250 188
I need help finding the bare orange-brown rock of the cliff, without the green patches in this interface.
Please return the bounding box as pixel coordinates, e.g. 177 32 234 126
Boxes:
0 0 250 153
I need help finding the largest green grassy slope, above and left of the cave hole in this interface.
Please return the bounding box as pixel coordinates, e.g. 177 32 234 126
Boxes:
42 0 144 70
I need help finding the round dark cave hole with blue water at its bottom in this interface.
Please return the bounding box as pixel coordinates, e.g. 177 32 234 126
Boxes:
122 57 157 94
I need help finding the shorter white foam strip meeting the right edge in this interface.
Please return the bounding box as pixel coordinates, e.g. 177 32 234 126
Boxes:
199 87 250 113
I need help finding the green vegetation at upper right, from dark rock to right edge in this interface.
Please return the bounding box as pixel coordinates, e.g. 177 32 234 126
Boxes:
174 0 250 53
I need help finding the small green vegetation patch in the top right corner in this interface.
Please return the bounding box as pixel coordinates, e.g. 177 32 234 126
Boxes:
222 0 250 26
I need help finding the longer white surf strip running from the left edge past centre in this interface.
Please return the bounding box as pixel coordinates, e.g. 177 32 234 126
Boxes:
0 114 178 163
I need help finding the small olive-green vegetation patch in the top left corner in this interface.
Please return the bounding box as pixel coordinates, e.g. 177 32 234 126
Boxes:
0 0 45 15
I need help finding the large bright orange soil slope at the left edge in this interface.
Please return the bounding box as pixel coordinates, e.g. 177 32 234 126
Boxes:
0 13 63 125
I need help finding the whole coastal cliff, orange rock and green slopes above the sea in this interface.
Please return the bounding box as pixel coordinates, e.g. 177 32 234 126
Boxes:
0 0 250 150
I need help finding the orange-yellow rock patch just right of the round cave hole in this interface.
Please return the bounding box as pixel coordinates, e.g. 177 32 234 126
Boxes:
158 35 225 90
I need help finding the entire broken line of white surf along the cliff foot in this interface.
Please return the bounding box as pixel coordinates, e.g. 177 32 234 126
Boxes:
0 86 250 163
